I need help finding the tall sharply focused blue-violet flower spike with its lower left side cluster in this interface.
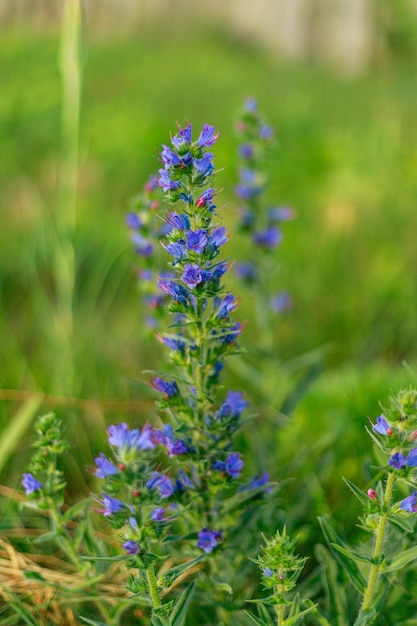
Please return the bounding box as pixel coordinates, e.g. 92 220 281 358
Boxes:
95 124 268 560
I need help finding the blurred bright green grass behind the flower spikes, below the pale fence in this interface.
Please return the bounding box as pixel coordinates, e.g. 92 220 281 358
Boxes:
0 2 417 560
